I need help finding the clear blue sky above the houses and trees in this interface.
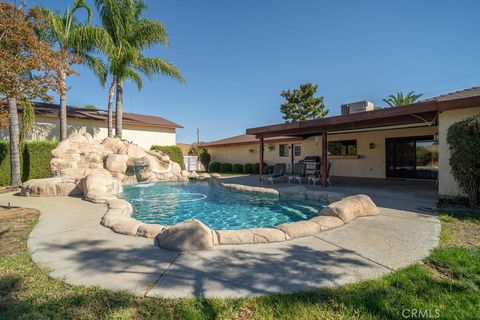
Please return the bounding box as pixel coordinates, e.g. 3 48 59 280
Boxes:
21 0 480 143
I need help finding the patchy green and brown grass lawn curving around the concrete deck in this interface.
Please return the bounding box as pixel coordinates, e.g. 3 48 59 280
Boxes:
0 207 480 319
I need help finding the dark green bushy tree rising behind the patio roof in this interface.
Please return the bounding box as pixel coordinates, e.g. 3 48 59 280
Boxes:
280 83 329 122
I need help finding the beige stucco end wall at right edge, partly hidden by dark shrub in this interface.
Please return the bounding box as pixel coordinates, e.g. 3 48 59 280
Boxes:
438 107 480 197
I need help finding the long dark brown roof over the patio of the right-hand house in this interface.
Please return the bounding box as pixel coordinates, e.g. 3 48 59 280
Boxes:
246 87 480 138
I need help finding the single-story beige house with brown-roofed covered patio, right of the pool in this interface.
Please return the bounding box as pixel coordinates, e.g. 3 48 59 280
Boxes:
203 87 480 197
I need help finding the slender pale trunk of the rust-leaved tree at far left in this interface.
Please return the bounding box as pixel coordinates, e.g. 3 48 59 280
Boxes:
8 98 22 187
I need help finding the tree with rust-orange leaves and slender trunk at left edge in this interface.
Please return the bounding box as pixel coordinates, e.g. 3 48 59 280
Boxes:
0 2 71 187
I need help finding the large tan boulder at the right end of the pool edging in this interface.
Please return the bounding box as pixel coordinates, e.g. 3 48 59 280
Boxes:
320 194 380 223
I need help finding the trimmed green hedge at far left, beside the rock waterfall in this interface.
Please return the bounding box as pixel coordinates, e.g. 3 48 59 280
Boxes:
0 141 58 186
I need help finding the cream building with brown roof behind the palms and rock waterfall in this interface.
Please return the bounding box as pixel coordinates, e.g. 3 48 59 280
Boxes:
0 102 183 149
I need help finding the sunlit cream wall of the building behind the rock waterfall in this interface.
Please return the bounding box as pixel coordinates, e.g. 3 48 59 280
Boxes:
0 117 176 149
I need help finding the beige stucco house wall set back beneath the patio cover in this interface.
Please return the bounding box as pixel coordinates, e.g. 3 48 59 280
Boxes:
208 126 437 178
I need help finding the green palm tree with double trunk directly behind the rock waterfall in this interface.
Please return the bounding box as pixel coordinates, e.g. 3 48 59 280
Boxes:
95 0 185 138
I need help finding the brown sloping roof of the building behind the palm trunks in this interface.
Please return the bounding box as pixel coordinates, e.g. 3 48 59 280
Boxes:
9 102 183 128
